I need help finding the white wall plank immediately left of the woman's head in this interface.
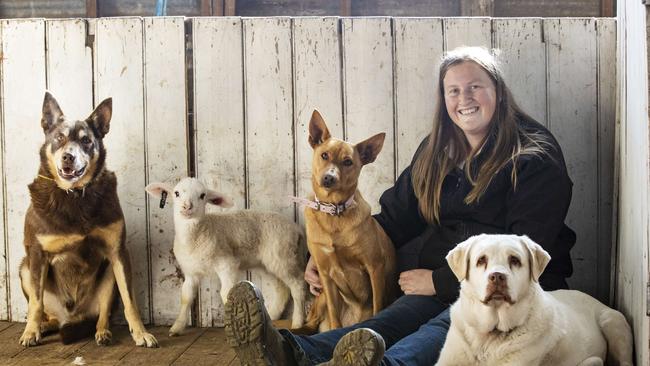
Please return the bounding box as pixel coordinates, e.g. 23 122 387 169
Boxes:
393 18 444 175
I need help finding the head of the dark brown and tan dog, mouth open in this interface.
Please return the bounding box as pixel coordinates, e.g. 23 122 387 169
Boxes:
40 92 112 190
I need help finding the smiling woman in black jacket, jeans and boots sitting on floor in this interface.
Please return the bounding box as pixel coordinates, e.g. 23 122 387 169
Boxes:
226 47 575 365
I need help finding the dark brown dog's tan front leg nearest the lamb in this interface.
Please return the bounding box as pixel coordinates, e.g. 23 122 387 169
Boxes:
111 247 158 347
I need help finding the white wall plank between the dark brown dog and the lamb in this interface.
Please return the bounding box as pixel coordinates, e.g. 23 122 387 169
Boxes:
95 18 150 323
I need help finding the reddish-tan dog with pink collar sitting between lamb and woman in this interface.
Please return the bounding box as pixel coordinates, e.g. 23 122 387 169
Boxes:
302 111 397 332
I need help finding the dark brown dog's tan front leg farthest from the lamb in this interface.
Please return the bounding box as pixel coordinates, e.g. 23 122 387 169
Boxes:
19 258 49 347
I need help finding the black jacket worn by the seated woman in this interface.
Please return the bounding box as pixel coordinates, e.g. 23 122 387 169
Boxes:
375 122 576 303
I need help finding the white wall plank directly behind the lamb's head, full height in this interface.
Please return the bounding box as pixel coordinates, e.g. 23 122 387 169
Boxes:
144 17 188 325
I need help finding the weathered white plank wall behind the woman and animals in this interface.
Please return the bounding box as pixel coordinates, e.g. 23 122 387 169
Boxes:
0 17 616 325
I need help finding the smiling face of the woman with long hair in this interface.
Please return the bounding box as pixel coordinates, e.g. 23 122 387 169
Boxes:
443 61 496 149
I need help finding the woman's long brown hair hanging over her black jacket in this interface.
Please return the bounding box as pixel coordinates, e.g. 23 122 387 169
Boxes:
412 47 549 223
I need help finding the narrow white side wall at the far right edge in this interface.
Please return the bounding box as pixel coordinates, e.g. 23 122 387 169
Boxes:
614 0 650 365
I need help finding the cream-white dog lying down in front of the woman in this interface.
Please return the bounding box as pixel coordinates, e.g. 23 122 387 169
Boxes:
437 235 632 366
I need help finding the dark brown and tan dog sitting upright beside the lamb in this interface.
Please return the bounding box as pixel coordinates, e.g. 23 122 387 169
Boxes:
20 93 157 347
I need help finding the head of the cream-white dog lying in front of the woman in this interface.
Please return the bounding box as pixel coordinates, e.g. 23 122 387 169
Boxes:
446 234 551 306
